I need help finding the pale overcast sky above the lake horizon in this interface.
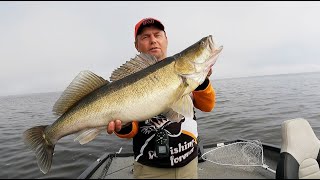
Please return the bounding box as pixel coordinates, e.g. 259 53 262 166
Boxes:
0 1 320 96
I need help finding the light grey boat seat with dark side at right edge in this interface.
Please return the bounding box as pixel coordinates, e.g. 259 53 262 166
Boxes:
276 118 320 179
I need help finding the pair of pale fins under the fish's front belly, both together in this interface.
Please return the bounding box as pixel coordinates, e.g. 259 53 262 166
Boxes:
164 94 194 122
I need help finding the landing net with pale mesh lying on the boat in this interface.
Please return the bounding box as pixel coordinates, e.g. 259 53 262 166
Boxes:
202 140 275 173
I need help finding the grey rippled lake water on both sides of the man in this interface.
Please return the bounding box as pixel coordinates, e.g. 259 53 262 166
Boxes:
0 73 320 179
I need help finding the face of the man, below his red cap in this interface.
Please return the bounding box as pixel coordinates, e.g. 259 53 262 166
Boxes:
135 26 168 60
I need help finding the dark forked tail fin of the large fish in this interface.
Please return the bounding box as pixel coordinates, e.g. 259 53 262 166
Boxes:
23 126 54 174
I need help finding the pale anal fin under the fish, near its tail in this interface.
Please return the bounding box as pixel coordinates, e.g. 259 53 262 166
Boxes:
74 127 105 145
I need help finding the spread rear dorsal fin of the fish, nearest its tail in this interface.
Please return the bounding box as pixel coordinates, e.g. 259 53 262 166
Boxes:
52 70 109 115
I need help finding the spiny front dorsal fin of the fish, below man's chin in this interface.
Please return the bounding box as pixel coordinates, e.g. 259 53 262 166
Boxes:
110 53 159 81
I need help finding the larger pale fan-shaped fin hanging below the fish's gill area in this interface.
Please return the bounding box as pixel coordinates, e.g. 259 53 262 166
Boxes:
168 94 194 121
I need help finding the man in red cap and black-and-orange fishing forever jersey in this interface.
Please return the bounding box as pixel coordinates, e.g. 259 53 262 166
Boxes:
107 18 220 179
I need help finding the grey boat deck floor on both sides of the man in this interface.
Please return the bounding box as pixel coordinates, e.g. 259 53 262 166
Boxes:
85 143 279 179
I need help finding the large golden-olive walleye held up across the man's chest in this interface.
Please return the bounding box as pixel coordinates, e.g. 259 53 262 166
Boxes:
23 35 222 174
